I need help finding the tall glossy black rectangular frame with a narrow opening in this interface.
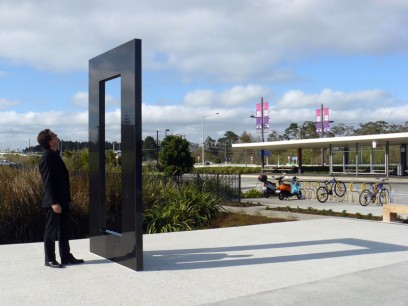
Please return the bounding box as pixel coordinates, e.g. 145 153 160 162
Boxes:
89 39 143 271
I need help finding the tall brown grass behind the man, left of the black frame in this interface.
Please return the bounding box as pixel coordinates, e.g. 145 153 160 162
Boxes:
0 156 89 244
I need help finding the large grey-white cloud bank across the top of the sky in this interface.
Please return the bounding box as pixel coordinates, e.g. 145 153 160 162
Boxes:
0 0 408 82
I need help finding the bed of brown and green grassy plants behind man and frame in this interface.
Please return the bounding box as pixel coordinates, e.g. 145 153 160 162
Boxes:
0 154 233 244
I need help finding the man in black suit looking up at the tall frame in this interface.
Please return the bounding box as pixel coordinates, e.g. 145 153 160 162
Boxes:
37 129 84 268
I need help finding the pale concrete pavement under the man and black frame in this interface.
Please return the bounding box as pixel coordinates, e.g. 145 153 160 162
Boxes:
0 212 408 306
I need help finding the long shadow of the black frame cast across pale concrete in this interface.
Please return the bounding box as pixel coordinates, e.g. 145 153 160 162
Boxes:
144 238 408 271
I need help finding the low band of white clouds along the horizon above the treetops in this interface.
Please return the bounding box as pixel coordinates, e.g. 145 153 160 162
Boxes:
0 86 408 151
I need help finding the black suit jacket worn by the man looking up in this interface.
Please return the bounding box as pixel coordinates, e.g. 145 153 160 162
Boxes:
39 150 71 207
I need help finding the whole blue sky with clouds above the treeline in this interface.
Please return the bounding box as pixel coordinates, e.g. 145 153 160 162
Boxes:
0 0 408 151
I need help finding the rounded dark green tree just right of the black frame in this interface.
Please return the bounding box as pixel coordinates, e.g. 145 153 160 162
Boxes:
160 135 194 176
